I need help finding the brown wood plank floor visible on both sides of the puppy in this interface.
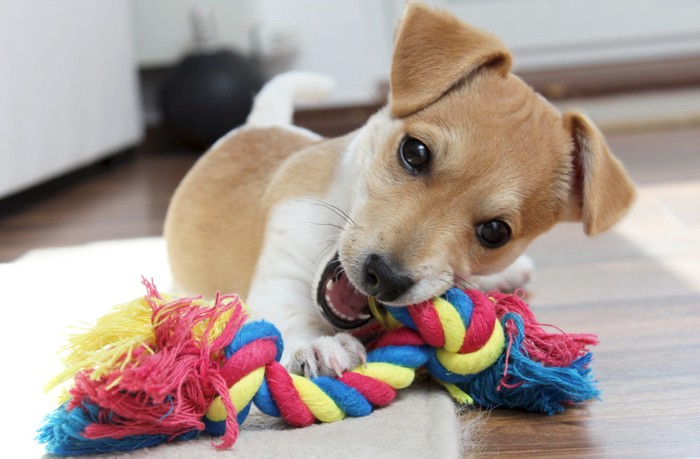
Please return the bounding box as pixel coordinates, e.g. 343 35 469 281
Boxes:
0 120 700 458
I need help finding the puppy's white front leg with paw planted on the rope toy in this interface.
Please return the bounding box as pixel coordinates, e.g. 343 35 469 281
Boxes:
247 201 366 376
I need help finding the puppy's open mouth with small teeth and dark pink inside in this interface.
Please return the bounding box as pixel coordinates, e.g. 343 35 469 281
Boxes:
316 254 372 330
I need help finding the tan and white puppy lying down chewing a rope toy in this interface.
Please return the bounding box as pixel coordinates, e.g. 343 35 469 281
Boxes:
165 4 634 375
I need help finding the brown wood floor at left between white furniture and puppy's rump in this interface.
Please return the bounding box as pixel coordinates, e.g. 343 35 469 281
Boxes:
0 149 197 262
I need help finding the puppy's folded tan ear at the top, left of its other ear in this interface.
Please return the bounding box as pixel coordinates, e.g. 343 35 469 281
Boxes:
390 3 511 117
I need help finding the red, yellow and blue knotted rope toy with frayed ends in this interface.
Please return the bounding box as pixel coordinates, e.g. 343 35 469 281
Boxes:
38 279 598 455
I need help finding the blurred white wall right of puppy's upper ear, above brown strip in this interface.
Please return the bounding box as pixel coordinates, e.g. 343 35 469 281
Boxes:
430 0 700 69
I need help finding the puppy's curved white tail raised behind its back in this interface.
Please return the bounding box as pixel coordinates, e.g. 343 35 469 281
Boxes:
246 71 335 126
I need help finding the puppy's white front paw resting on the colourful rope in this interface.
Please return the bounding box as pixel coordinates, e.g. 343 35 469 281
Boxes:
287 333 367 377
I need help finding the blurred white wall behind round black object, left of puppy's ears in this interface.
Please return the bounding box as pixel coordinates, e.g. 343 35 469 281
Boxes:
131 0 395 104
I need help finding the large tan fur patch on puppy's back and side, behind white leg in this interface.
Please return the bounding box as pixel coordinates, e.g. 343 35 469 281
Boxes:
165 128 344 297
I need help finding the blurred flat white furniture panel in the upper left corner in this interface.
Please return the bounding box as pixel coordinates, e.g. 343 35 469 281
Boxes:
0 0 142 196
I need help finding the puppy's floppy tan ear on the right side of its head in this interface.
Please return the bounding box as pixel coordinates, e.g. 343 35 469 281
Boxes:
563 112 635 236
